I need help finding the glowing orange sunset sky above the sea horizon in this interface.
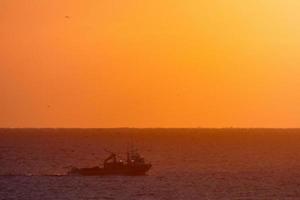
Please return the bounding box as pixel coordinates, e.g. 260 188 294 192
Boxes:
0 0 300 128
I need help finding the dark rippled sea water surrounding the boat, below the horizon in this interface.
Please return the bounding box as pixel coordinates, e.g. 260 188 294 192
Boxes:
0 129 300 200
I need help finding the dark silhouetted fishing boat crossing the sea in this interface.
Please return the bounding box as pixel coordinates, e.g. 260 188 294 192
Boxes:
68 150 152 176
